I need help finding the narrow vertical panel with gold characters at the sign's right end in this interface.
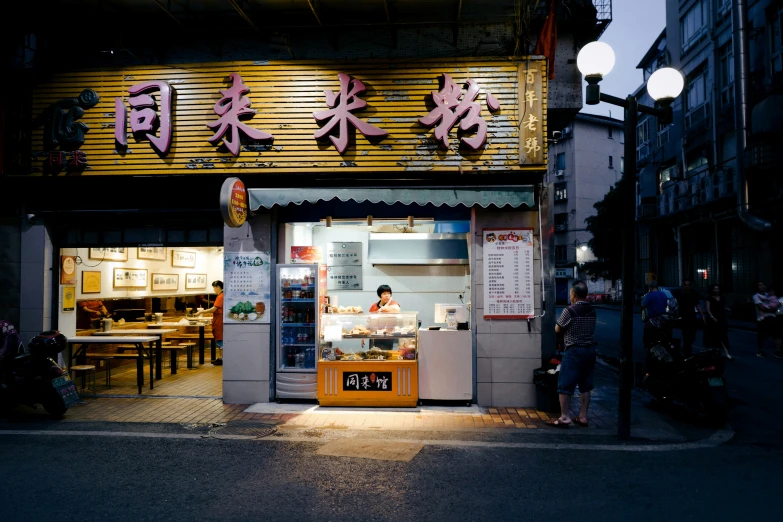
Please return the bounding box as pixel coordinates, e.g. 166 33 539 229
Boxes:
519 61 546 165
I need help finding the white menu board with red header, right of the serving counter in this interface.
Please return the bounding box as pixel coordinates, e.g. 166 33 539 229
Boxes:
482 228 534 319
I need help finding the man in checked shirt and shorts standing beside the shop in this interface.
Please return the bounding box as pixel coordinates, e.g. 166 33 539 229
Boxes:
547 280 596 428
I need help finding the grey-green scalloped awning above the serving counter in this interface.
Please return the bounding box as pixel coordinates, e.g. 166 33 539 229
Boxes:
248 185 535 210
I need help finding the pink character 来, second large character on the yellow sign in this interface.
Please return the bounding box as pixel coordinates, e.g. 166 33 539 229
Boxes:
207 73 274 156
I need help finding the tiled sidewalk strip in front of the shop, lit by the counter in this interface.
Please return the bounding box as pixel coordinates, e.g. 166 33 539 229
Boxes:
0 363 713 443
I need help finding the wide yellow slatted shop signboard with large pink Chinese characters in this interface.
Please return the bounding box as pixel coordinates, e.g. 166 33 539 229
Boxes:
31 58 547 173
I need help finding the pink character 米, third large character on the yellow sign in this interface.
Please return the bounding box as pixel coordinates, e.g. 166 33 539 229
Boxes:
313 73 389 154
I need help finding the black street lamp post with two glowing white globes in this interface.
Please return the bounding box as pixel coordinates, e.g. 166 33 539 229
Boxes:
576 42 684 440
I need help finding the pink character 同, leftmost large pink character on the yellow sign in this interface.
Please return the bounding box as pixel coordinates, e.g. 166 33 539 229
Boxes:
114 81 173 155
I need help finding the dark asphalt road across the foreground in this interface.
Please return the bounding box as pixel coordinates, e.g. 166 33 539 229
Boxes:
0 424 783 522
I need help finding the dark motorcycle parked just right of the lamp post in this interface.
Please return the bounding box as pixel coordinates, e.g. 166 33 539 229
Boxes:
644 324 729 428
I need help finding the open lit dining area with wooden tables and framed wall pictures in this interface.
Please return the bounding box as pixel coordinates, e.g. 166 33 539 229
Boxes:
56 236 223 399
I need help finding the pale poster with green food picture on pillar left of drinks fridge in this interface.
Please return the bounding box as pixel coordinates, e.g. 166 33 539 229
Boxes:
223 252 271 323
